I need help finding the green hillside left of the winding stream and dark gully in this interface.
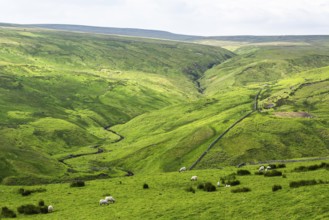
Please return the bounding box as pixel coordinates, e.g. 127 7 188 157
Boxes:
0 24 234 183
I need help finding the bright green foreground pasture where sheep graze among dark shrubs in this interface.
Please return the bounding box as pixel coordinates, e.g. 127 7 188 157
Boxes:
0 161 329 219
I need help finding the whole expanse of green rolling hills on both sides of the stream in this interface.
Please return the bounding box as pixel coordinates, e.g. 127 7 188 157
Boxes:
0 25 329 184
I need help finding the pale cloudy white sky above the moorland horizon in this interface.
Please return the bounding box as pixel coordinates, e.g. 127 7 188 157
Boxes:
0 0 329 36
